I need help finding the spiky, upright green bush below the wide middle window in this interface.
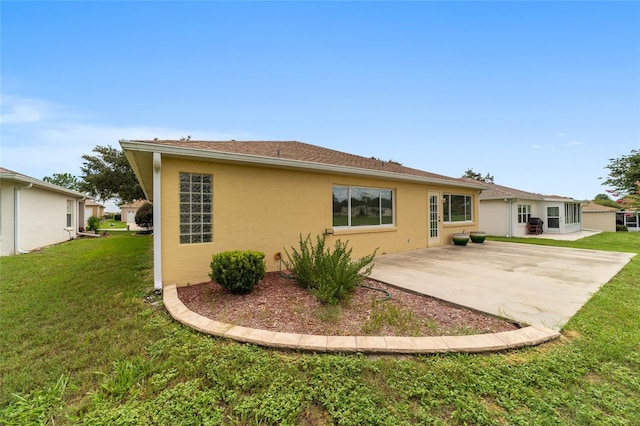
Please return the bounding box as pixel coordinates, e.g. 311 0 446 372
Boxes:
284 235 377 305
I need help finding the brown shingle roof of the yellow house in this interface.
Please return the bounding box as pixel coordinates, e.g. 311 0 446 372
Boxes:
129 140 482 187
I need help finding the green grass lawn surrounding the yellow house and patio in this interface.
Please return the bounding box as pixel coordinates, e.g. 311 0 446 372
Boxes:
0 233 640 425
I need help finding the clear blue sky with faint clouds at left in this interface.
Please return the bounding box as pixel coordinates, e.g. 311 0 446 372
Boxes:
0 1 640 211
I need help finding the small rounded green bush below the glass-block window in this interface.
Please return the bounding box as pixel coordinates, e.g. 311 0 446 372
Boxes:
209 250 265 294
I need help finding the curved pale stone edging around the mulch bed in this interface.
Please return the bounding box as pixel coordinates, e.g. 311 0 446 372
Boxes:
162 284 560 354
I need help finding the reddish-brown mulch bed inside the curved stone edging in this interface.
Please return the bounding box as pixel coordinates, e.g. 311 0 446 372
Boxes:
178 272 518 336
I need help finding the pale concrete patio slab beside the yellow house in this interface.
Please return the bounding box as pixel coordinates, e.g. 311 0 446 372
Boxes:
371 241 634 330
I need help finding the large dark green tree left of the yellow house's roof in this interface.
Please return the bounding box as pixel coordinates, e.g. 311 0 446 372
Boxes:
80 145 144 204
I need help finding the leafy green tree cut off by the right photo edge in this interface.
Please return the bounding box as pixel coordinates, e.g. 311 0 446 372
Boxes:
602 149 640 208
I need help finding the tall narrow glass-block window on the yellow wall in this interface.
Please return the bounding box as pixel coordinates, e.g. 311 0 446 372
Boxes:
180 173 213 244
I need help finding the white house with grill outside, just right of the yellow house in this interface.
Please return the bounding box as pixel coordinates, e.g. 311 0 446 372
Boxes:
480 184 582 237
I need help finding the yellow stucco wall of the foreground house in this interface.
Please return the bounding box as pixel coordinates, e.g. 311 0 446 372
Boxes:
161 158 478 285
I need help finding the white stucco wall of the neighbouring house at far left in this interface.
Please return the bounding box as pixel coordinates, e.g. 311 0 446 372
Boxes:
2 183 78 255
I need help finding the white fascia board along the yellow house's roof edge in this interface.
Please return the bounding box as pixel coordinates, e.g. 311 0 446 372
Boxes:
120 140 487 189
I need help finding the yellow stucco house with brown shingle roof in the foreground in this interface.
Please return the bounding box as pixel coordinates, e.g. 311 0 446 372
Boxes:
120 140 486 289
